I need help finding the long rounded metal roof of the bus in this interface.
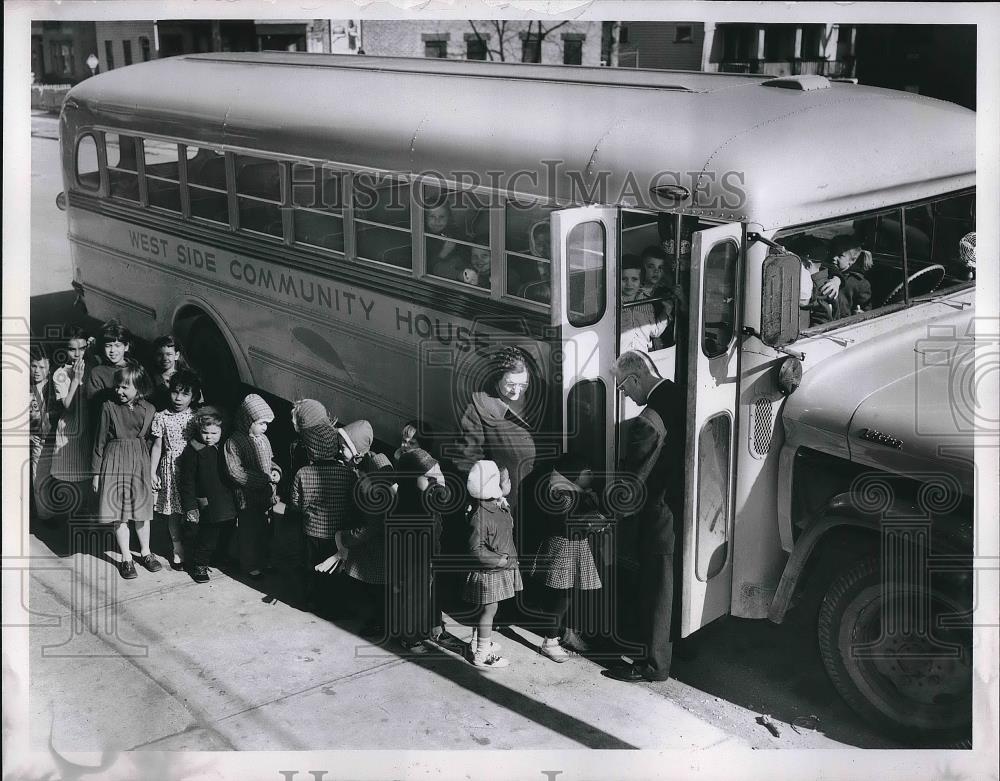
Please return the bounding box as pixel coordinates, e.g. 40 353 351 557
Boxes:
64 53 976 228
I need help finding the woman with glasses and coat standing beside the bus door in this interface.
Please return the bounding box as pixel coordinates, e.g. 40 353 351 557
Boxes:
455 347 535 517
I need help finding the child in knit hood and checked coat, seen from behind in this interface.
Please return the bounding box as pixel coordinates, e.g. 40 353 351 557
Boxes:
289 399 358 609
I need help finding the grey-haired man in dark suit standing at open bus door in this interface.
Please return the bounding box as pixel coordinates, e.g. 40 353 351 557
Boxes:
605 351 684 682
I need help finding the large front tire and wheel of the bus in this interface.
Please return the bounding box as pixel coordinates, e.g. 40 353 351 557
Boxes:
818 556 972 747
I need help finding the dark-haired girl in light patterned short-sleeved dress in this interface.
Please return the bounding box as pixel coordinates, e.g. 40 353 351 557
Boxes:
149 369 201 571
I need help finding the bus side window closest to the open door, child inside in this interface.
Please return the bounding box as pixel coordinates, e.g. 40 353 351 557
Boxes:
504 200 554 305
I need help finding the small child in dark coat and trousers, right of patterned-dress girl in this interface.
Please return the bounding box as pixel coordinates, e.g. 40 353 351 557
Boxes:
177 407 236 583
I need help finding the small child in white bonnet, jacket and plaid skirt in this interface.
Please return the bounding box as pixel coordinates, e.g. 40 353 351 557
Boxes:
462 460 524 670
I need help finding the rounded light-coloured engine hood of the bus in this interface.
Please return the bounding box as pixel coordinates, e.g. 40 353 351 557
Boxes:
783 309 972 494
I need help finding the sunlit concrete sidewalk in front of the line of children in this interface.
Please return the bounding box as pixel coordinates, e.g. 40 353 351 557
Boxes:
29 537 745 752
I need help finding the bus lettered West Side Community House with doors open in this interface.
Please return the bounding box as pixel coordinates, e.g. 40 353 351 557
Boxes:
60 53 975 743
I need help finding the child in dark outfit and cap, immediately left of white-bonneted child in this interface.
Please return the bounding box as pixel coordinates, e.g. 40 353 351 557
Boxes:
390 447 448 654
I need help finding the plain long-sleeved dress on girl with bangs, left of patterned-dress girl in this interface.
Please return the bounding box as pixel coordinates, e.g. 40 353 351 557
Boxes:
93 399 155 523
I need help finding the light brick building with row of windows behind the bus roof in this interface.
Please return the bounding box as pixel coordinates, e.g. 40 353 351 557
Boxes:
361 19 601 65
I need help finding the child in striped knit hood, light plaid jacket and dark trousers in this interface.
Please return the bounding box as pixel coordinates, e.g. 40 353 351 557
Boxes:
223 393 274 578
